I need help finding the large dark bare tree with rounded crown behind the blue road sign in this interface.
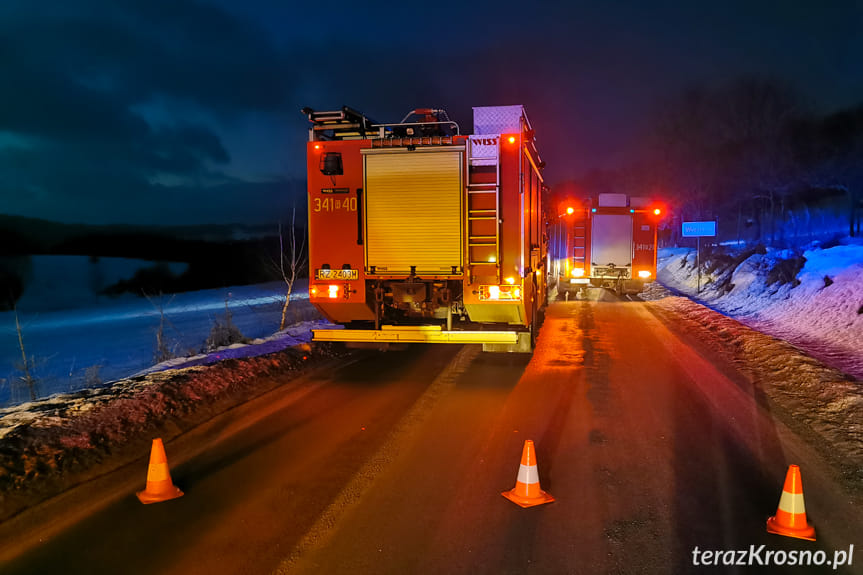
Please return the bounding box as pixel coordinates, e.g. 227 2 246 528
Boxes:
648 78 801 244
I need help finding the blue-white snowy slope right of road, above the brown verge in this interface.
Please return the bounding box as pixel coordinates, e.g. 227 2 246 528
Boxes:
658 238 863 380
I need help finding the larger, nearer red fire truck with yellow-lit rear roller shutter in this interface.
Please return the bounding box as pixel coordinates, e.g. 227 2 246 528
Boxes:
303 106 546 351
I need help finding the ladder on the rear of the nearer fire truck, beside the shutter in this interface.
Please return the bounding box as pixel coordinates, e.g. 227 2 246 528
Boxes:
467 136 501 283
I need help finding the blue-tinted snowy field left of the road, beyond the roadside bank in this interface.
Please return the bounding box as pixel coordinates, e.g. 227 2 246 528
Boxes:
0 267 313 405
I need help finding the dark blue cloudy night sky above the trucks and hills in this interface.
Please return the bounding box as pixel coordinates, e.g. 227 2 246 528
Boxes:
0 0 863 224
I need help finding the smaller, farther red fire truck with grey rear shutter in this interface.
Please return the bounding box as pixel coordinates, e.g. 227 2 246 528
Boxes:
549 194 663 297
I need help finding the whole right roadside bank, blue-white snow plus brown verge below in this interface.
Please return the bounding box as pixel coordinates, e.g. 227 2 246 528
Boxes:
660 238 863 485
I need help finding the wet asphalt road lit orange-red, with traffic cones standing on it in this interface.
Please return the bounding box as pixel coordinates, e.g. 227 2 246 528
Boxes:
0 301 863 575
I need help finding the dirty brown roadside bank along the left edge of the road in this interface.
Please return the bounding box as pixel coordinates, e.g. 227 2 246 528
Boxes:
0 336 348 521
